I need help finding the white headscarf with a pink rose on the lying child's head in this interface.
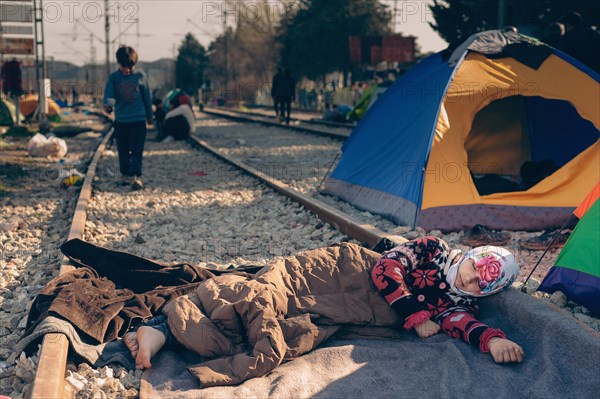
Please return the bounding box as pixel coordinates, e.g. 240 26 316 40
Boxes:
446 245 520 297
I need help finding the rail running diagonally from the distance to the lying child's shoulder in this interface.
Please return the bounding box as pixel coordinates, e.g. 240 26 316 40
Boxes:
191 137 406 250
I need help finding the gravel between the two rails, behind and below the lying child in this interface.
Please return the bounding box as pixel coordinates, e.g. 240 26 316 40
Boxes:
61 122 354 398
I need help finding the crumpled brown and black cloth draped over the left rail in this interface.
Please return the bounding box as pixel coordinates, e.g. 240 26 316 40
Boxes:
24 239 260 344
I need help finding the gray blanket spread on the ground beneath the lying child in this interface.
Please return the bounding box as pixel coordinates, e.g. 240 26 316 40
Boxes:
140 290 600 399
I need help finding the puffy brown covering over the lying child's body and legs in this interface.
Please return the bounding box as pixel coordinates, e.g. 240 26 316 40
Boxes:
163 243 400 387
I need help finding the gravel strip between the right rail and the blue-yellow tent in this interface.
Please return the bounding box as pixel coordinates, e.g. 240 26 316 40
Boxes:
197 114 557 280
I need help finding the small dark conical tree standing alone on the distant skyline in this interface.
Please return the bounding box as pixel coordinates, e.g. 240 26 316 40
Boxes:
175 33 207 95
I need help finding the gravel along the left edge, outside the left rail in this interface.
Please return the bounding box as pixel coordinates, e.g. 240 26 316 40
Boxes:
0 130 104 398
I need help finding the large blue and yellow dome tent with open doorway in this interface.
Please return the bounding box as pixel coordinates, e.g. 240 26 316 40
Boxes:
325 31 600 231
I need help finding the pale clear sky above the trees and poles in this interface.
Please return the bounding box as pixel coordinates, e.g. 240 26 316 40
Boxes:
39 0 446 65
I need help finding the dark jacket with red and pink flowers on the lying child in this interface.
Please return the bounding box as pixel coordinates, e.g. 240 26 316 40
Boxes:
371 237 505 352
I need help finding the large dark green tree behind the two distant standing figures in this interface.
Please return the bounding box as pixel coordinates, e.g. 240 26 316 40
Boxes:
279 0 392 79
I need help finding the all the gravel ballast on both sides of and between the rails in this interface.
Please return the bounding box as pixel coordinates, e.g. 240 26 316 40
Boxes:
0 115 598 398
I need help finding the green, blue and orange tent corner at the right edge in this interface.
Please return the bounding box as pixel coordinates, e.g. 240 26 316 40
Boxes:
539 183 600 314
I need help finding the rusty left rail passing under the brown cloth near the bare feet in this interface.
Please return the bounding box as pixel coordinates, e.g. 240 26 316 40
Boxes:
31 130 113 399
